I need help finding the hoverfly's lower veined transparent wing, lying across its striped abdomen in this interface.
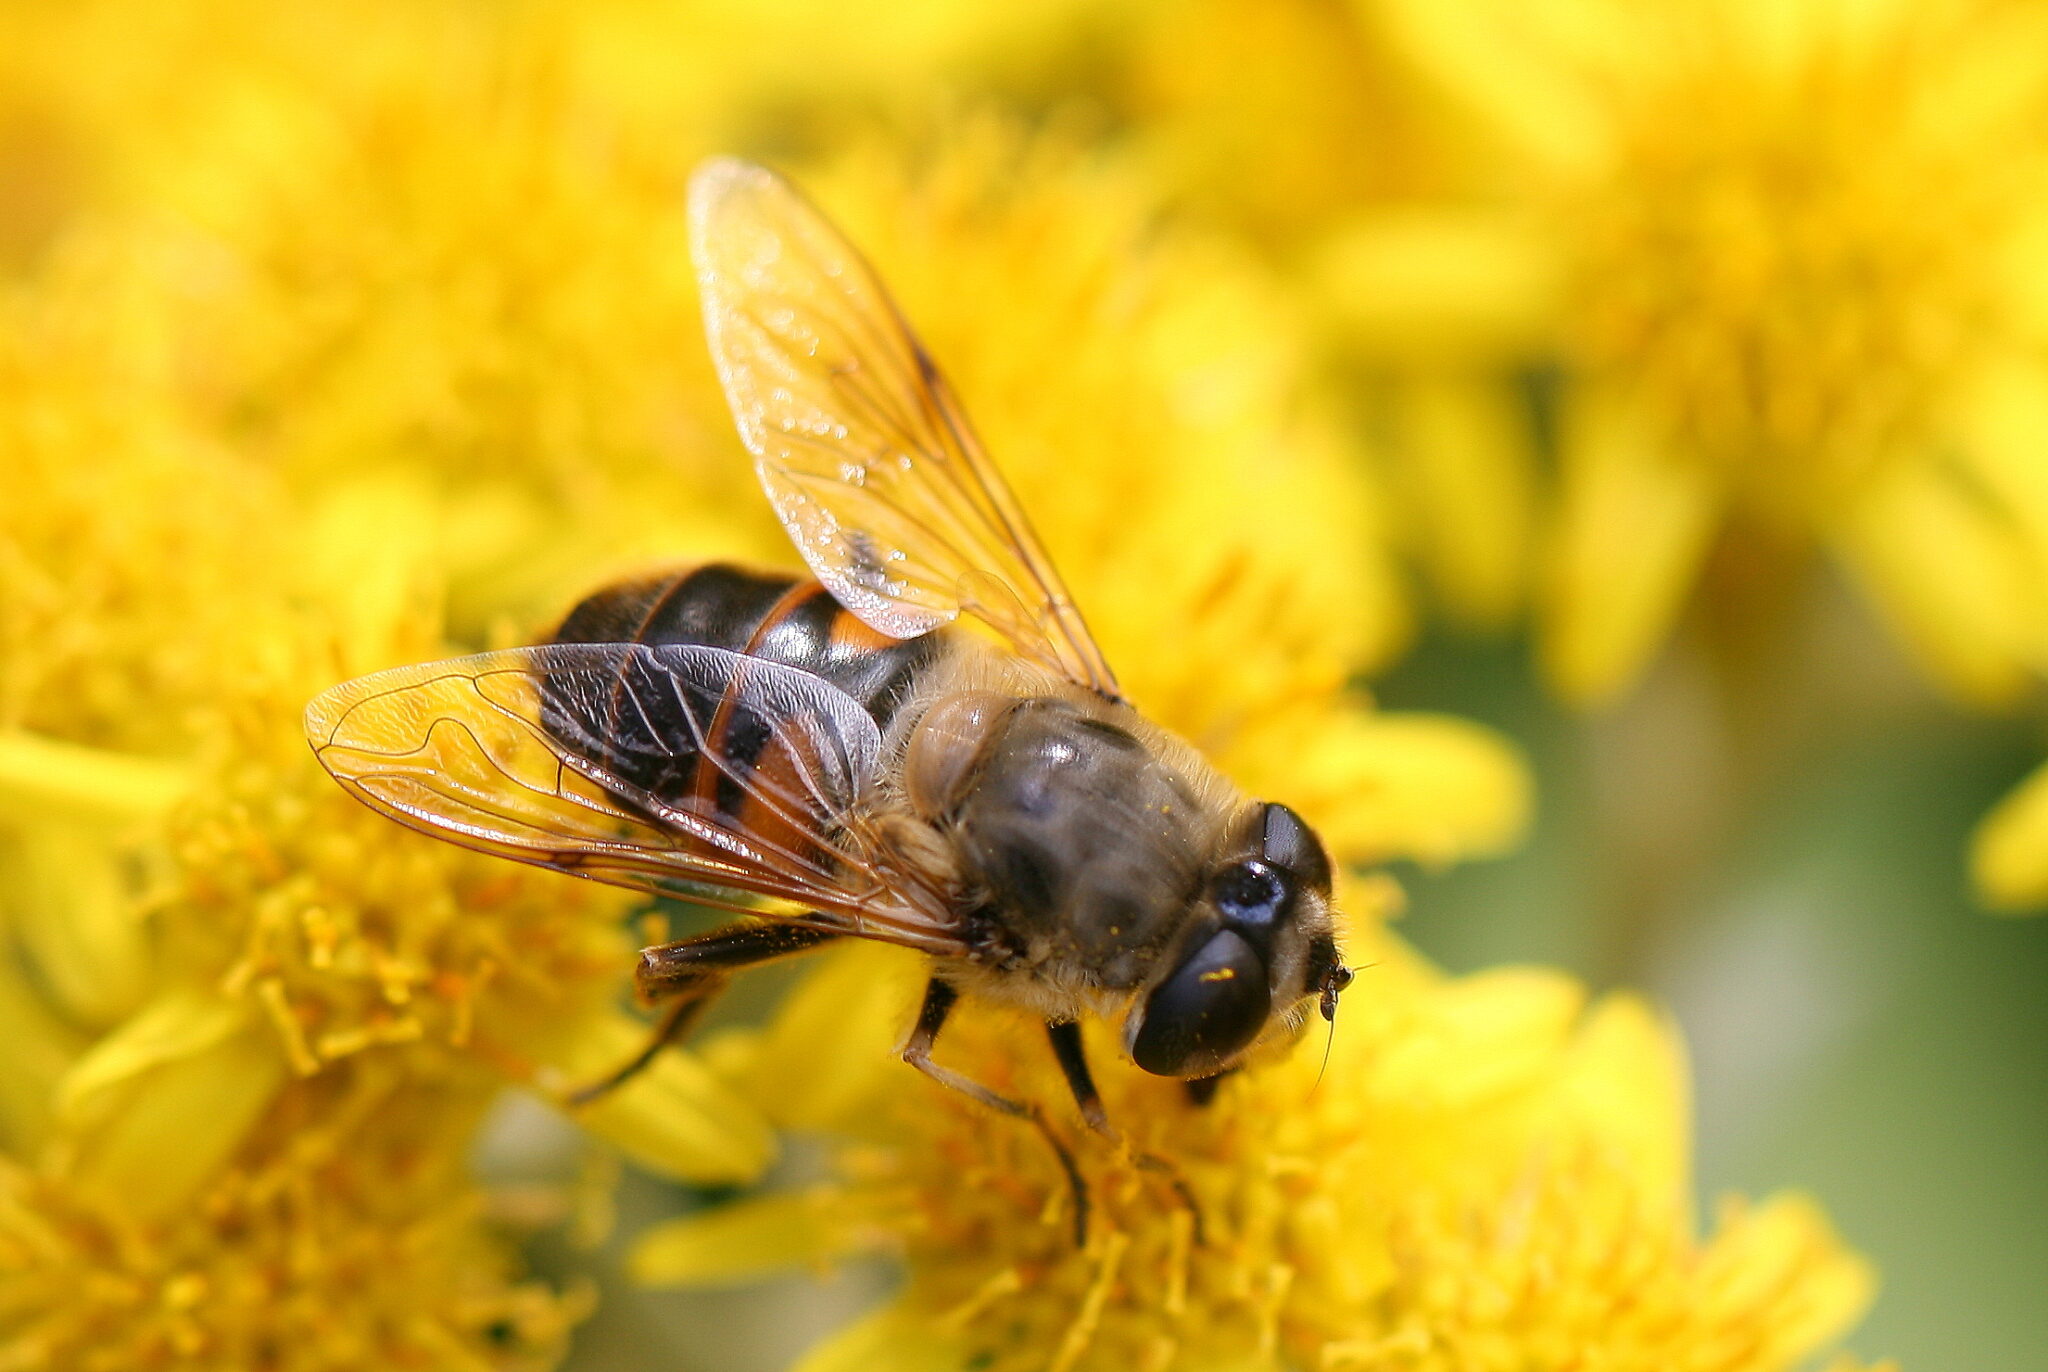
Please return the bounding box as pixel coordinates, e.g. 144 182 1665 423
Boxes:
305 643 961 952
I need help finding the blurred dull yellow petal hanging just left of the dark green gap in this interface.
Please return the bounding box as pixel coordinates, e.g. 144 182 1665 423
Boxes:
1393 373 1534 629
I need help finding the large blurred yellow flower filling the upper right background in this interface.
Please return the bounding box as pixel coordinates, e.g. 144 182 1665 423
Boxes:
1269 0 2048 909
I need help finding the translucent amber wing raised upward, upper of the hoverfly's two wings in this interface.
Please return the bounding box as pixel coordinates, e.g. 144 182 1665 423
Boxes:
690 158 1116 696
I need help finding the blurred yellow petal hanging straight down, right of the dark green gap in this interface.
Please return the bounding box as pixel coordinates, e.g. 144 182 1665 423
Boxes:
1542 391 1718 704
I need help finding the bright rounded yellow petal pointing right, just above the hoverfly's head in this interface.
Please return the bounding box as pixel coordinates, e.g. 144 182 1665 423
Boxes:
1225 709 1532 862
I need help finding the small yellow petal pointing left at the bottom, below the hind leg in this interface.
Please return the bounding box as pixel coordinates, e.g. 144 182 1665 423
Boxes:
627 1190 858 1286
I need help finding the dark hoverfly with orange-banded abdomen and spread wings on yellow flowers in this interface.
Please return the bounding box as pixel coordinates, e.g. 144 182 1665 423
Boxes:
305 160 1352 1223
